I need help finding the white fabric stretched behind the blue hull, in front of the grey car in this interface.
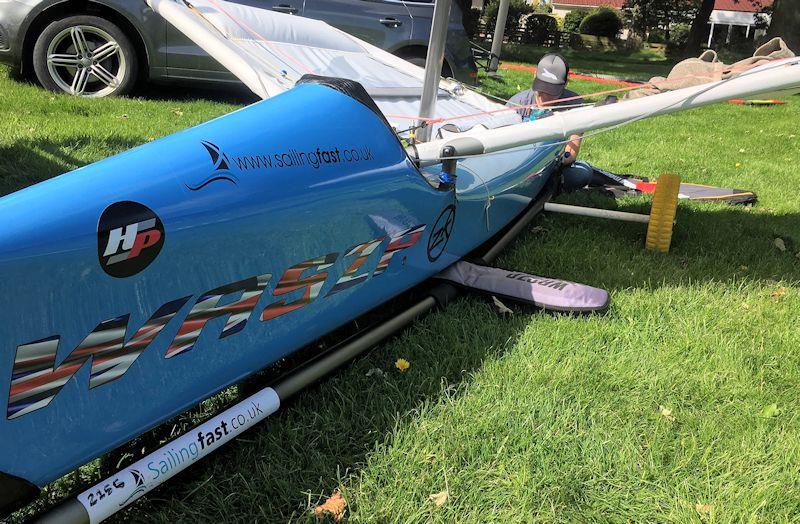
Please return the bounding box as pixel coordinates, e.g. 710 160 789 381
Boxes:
147 0 521 135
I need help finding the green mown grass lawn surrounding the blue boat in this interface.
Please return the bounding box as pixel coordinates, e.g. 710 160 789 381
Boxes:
0 54 800 524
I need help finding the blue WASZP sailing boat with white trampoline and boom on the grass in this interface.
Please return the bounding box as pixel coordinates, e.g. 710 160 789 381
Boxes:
0 0 800 522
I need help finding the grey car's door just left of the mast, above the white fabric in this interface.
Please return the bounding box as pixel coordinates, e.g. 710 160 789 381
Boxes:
303 0 413 52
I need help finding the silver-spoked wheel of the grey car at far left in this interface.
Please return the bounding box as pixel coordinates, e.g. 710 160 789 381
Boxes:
33 16 138 97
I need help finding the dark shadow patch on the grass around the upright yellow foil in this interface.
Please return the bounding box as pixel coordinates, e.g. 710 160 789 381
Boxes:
524 195 800 291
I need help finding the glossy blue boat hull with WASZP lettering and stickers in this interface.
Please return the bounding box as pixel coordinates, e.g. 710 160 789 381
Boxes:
0 84 560 486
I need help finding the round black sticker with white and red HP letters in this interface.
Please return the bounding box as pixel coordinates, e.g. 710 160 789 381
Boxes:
97 201 164 278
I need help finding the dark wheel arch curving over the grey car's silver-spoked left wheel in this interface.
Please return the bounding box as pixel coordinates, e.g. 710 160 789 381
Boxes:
22 0 150 78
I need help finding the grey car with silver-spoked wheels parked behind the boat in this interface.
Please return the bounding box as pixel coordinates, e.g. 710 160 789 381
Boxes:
0 0 477 97
